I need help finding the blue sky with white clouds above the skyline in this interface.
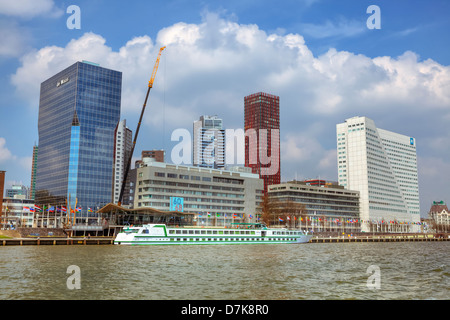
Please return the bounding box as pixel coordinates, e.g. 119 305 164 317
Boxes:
0 0 450 217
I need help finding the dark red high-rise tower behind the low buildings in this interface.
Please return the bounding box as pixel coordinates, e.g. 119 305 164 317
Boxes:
244 92 281 193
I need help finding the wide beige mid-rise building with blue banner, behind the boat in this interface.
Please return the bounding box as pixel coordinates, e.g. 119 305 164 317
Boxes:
133 158 263 226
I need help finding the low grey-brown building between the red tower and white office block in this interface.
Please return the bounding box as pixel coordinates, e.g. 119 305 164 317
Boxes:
267 180 361 233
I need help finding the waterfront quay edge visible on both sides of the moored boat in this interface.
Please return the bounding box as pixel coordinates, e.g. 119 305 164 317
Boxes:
0 233 450 246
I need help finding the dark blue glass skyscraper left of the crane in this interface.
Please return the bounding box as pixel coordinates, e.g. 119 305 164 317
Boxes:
36 62 122 212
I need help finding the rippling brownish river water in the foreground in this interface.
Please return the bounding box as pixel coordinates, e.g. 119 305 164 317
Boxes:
0 242 450 300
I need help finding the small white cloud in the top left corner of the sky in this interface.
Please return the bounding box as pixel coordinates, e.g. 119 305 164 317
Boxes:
0 0 63 18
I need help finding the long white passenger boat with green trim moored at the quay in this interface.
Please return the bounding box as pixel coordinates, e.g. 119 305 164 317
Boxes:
114 223 312 245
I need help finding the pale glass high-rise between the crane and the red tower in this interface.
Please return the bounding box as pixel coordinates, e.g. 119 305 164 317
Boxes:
192 116 225 169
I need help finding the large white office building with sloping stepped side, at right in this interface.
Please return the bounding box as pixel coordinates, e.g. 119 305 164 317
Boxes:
336 117 420 232
